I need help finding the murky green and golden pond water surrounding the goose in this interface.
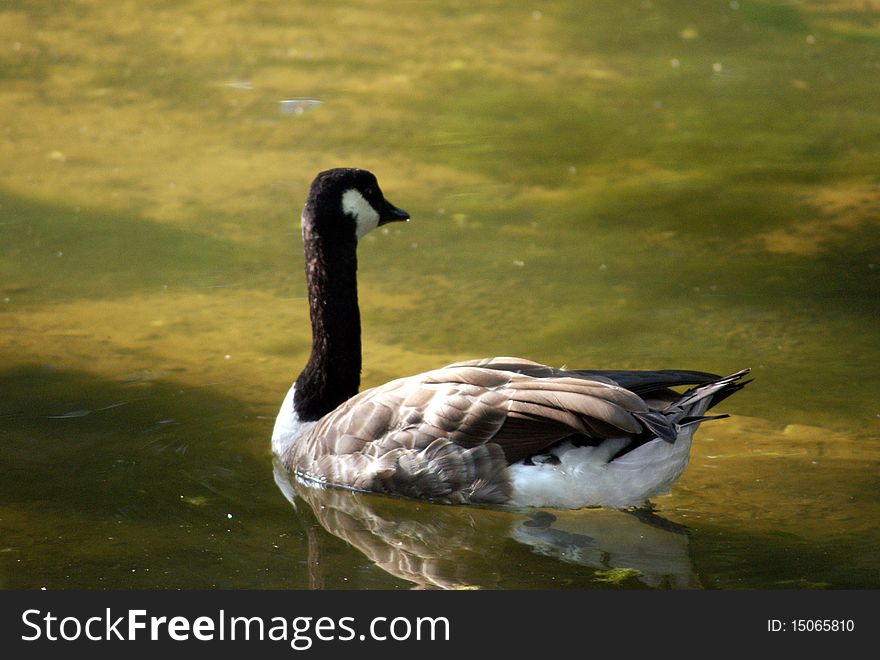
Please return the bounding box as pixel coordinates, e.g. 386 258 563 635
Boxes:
0 0 880 589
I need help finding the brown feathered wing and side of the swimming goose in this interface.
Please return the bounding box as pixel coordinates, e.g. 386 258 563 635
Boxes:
292 361 648 502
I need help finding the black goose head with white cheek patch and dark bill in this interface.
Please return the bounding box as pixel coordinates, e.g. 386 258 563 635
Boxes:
303 167 409 241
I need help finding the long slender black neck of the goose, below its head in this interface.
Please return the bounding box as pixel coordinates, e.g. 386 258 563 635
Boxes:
293 218 361 421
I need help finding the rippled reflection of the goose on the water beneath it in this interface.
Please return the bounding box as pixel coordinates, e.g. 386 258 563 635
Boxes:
275 463 700 589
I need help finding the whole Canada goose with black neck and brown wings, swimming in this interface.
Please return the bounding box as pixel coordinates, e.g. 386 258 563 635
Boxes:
272 169 748 508
